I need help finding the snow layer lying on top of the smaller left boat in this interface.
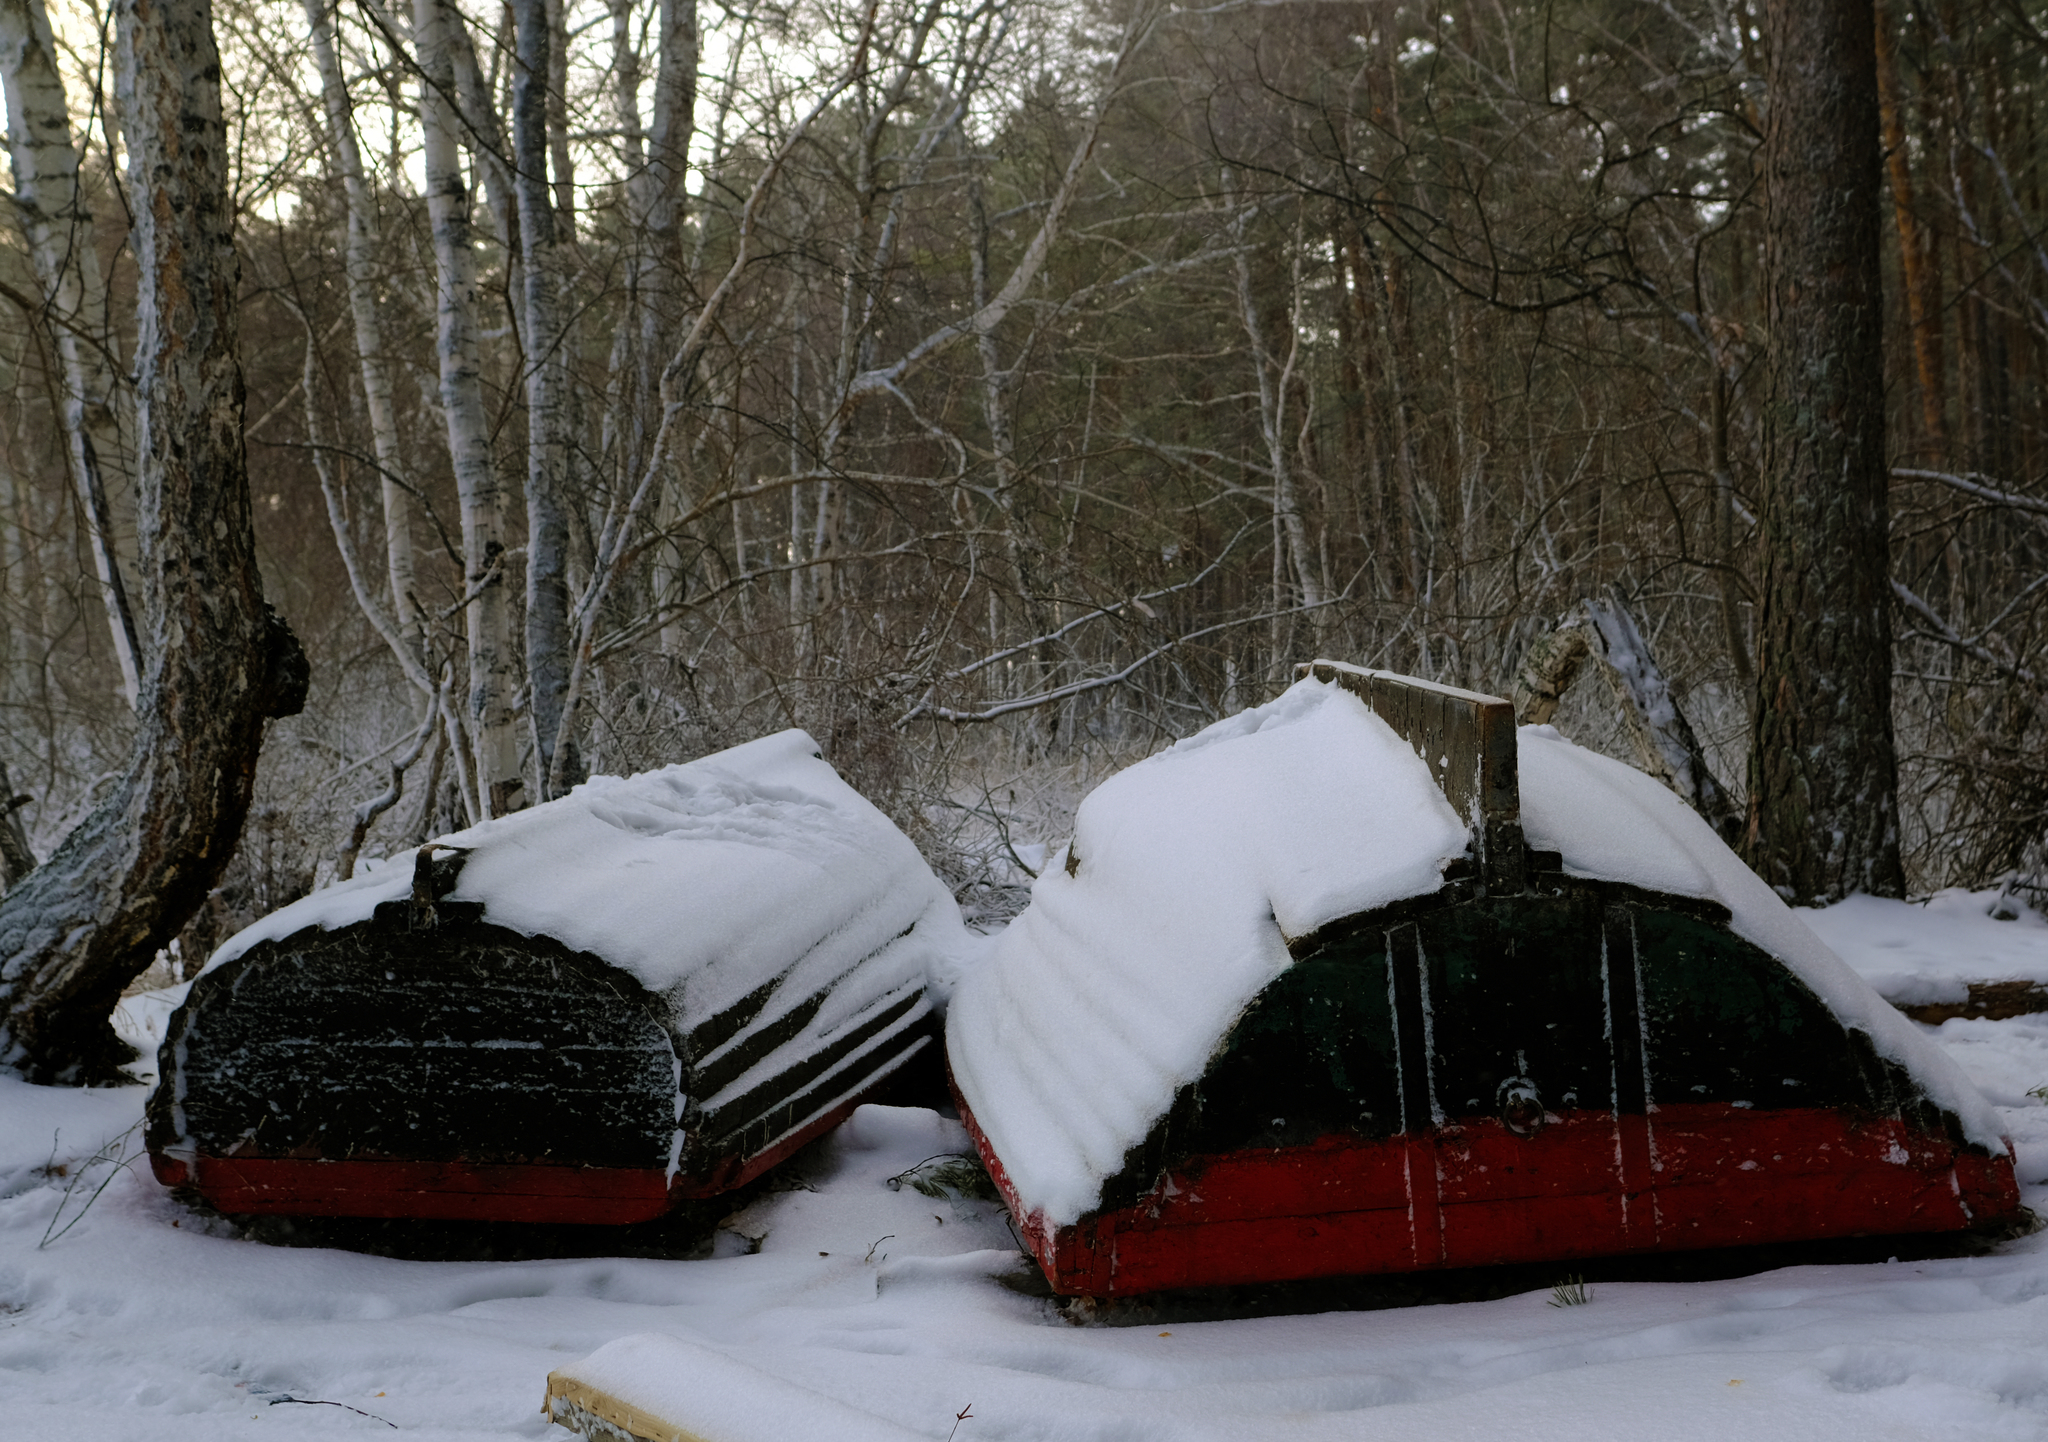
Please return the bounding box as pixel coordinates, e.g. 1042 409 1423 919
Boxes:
207 731 965 1026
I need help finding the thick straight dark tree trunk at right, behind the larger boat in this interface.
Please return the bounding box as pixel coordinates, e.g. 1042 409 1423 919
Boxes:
1745 0 1905 901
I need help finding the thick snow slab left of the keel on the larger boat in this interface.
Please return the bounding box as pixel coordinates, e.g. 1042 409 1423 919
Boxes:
946 680 1466 1225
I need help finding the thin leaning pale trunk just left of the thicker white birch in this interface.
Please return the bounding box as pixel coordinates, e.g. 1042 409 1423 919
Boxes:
305 0 424 647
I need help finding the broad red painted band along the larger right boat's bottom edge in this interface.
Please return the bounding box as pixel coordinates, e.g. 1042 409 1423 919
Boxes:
961 1104 2019 1297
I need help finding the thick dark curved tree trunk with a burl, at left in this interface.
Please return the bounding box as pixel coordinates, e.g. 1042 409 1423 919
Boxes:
0 0 307 1084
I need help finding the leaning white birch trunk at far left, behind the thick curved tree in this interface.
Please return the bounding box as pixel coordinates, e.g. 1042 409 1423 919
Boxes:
0 0 141 707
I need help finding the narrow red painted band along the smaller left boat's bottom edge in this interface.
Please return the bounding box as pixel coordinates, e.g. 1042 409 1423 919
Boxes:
150 1096 866 1227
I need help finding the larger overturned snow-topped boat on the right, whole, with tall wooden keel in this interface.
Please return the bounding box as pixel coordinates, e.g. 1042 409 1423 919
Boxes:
946 662 2021 1297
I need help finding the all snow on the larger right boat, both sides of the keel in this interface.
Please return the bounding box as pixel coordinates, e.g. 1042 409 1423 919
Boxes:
946 678 2003 1227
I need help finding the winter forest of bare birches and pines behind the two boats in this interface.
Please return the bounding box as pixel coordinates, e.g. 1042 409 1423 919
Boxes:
0 0 2048 1075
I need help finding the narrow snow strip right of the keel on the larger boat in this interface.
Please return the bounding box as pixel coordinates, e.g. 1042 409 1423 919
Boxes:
1520 725 2005 1151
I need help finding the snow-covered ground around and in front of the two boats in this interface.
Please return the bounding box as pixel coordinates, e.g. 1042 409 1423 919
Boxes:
0 899 2048 1442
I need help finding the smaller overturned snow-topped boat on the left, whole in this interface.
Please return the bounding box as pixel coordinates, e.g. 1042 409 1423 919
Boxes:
147 731 963 1223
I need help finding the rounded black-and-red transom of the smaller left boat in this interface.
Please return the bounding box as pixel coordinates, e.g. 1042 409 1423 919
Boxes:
147 920 678 1223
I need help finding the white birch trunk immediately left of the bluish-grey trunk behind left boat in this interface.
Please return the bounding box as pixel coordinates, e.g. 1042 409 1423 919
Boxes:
414 0 522 817
